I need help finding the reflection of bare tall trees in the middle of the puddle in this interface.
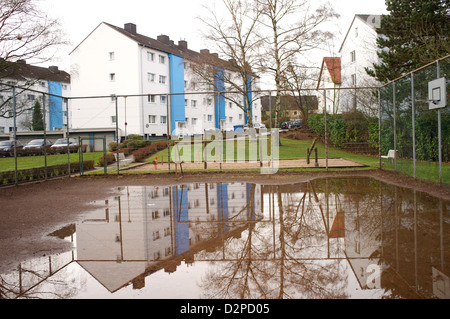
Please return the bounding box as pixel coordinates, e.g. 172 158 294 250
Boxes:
200 182 346 299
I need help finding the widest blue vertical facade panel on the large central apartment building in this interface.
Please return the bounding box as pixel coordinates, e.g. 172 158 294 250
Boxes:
169 54 186 132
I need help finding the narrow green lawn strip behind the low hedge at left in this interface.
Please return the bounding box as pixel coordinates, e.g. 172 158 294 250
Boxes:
0 152 103 172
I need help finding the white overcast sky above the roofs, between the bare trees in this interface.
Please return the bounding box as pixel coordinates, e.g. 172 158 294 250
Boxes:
41 0 387 86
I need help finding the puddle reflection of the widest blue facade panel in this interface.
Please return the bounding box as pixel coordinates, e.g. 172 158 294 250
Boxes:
173 186 189 255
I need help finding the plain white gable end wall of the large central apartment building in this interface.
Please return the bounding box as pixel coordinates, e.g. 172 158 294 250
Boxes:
70 23 142 134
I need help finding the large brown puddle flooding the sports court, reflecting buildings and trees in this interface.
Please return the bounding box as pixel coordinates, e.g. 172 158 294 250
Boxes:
0 177 450 299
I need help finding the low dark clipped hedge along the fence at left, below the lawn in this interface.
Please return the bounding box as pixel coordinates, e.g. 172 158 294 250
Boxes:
0 161 94 185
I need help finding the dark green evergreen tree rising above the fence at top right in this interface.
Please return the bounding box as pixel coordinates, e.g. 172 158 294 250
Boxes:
366 0 450 82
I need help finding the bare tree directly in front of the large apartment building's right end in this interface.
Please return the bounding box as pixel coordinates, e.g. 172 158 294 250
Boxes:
192 0 262 127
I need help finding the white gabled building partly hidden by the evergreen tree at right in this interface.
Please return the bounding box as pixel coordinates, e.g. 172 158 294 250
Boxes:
339 14 381 115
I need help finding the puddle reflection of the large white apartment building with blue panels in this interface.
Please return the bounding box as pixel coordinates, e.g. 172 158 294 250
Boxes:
76 183 262 291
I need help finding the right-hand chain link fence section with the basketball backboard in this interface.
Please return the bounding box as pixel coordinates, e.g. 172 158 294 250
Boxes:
380 57 450 188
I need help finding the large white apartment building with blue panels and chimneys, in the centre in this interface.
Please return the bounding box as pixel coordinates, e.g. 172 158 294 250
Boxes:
70 22 261 138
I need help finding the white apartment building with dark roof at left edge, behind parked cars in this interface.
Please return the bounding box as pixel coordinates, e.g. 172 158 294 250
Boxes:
0 60 70 135
